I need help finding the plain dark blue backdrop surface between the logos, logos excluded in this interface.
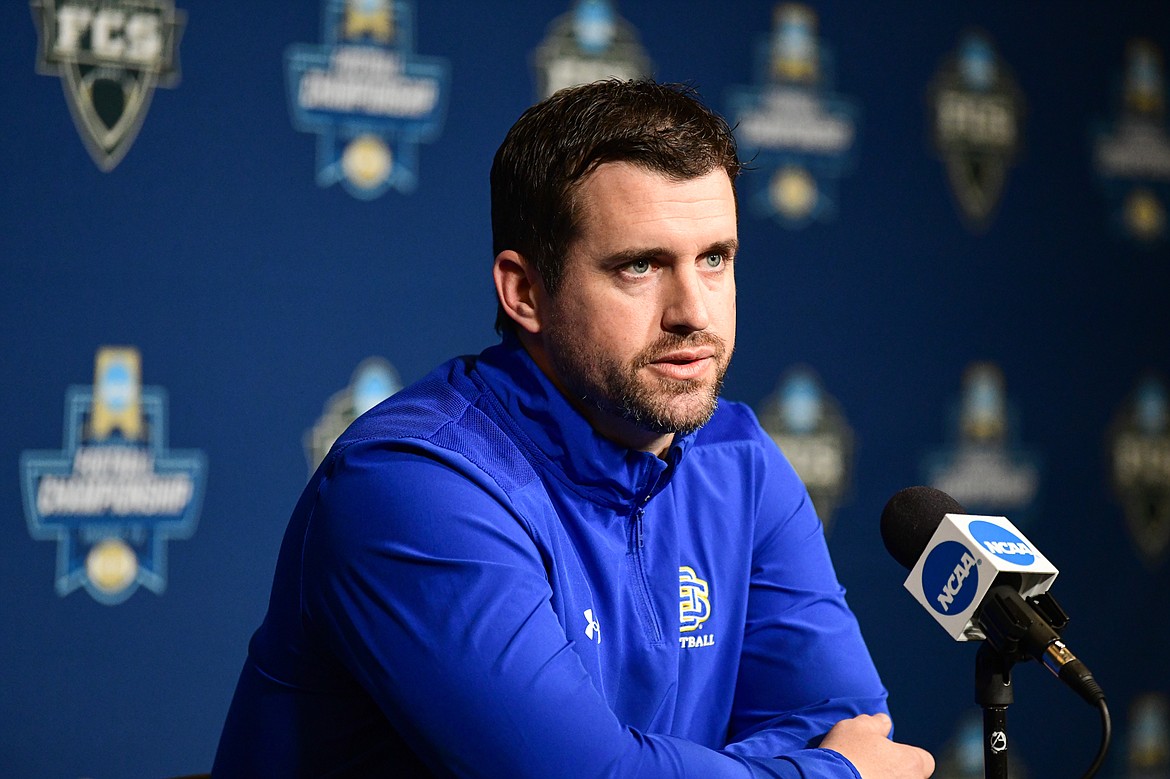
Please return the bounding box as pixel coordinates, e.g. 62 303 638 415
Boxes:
0 0 1170 779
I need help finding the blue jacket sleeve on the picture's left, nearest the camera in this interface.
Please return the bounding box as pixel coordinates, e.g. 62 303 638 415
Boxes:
302 444 856 779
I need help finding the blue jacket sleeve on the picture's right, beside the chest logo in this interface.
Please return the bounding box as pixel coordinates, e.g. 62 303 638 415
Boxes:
727 432 888 761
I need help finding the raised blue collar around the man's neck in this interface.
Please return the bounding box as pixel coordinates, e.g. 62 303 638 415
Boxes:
476 335 695 504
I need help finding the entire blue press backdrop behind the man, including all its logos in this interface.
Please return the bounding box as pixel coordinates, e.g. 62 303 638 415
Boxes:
0 0 1170 779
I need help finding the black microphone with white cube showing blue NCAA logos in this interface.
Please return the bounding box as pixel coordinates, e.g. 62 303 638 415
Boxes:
881 487 1104 704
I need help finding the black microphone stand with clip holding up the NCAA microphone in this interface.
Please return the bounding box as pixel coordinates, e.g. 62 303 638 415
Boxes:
975 584 1068 779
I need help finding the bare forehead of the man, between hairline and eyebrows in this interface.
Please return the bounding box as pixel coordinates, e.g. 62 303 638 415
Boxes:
574 163 736 253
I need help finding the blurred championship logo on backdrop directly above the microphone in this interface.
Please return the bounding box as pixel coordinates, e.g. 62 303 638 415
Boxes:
923 363 1040 524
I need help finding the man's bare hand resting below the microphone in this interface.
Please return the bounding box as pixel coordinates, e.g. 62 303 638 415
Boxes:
820 713 935 779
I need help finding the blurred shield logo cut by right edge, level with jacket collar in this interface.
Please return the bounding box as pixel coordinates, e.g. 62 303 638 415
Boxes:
1109 375 1170 565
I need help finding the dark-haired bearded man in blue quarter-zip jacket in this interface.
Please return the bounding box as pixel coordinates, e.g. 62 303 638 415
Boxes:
214 82 932 779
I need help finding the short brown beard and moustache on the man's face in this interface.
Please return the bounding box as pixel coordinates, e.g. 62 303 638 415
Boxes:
548 323 731 435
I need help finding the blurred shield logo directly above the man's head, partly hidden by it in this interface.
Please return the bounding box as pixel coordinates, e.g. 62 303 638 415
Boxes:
532 0 651 99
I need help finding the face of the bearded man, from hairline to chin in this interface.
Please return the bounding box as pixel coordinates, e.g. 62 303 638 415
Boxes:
538 163 737 451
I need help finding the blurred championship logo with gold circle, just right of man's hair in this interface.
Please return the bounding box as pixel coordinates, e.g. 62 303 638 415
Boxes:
728 4 859 227
